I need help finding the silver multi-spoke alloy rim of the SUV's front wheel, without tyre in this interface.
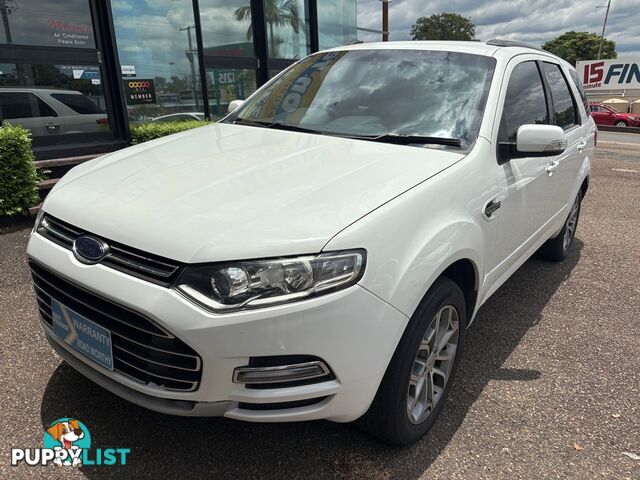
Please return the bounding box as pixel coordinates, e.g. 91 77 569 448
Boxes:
407 305 460 425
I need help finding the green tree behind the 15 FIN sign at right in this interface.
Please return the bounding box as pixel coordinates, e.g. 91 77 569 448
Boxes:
542 31 618 65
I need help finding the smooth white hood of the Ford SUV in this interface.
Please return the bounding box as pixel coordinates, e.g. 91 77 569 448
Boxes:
44 123 463 263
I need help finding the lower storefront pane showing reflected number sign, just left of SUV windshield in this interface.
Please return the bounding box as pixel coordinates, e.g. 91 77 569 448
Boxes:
207 68 256 120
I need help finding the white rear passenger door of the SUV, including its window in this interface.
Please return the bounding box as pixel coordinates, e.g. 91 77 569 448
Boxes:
542 61 588 221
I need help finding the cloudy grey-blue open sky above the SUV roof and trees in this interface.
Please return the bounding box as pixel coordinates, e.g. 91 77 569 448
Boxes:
358 0 640 57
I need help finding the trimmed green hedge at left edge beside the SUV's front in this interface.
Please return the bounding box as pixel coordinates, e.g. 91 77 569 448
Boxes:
0 123 40 216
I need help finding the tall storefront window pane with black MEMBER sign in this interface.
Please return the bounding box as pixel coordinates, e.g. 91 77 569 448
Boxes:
110 0 203 124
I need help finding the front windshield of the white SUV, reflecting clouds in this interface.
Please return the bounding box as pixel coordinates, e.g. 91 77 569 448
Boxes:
225 50 495 146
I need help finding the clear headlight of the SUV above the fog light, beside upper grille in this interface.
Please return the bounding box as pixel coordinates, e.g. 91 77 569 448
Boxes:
176 250 366 311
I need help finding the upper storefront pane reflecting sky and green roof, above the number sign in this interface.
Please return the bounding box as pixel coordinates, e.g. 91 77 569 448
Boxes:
200 0 254 57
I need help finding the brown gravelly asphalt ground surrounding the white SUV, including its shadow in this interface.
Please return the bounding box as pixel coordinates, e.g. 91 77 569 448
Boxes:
0 143 640 480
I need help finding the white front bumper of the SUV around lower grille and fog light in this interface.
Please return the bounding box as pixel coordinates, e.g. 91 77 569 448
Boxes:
27 233 408 422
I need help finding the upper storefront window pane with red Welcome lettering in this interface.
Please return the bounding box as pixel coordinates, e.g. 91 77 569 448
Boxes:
0 0 96 48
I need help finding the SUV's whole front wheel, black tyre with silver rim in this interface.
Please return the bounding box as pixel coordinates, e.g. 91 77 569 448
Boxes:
360 278 466 445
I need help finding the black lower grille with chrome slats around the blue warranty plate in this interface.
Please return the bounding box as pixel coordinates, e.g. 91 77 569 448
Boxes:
29 262 202 391
